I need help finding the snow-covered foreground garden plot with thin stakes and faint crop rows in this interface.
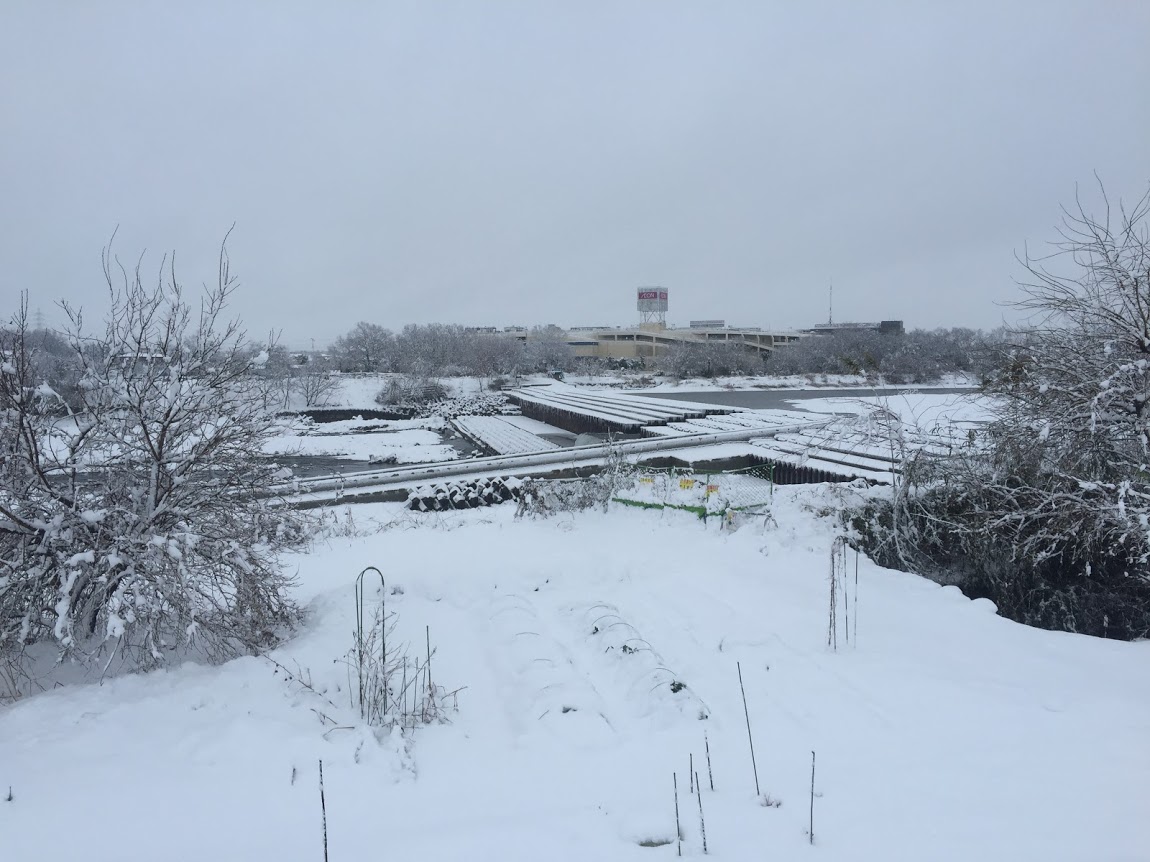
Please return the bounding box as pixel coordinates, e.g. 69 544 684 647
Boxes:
0 486 1150 862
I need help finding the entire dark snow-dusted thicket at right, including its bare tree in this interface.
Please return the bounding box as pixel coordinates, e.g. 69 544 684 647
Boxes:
857 183 1150 638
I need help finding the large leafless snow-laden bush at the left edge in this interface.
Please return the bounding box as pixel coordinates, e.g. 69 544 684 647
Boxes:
0 240 299 685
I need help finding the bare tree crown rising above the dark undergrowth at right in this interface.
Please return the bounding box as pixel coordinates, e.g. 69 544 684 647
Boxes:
989 179 1150 482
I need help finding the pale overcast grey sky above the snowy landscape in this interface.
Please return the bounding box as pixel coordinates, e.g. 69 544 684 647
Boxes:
0 0 1150 346
